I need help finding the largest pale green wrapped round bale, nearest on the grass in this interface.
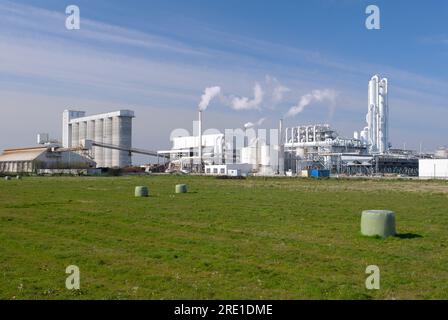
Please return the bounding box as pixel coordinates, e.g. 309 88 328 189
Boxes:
361 210 396 238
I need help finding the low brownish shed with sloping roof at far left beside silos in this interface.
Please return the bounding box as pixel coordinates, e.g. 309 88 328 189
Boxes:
0 146 96 173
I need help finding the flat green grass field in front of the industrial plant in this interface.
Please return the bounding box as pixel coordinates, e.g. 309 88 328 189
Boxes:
0 176 448 299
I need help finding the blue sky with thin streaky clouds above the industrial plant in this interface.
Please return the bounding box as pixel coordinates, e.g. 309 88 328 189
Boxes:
0 0 448 156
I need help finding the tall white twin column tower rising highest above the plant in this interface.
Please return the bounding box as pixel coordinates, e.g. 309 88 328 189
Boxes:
361 75 390 154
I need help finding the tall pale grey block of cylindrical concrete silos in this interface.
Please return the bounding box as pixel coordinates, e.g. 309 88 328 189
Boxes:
62 110 134 168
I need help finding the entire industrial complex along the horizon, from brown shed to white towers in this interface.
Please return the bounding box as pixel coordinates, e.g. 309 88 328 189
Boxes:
0 75 448 178
